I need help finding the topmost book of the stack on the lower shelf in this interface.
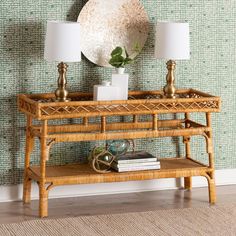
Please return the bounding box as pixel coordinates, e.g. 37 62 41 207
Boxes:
115 151 159 164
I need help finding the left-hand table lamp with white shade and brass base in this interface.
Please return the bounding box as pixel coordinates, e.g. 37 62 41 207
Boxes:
44 21 81 102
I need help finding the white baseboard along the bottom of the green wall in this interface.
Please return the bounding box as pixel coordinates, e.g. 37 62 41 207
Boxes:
0 169 236 202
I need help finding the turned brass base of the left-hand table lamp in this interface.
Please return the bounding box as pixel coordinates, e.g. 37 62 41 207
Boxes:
55 62 70 102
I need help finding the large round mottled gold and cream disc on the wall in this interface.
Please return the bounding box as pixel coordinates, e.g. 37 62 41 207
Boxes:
78 0 149 67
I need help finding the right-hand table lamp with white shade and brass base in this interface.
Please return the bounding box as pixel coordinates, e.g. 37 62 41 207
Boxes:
155 22 190 98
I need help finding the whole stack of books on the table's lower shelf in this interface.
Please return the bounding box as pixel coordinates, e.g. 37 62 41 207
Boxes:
112 152 160 172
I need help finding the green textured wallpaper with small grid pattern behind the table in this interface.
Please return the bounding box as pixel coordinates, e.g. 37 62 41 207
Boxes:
0 0 236 184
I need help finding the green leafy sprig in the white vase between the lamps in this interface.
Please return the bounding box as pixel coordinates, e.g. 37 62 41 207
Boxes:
109 43 140 68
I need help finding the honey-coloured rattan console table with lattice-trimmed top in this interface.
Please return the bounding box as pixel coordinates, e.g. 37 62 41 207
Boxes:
18 89 220 217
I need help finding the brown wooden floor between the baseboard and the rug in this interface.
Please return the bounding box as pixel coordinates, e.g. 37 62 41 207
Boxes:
0 185 236 223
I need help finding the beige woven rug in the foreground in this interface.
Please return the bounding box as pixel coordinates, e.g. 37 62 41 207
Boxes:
0 204 236 236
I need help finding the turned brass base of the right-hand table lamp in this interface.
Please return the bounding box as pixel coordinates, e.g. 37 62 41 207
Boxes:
163 60 176 98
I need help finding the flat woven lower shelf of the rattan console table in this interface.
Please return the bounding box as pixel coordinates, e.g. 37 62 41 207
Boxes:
28 158 213 185
